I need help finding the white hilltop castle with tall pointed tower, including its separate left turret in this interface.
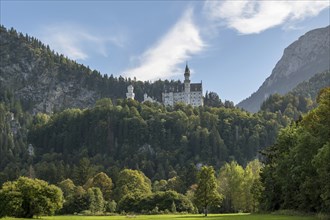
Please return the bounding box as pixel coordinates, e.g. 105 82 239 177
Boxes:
126 65 203 107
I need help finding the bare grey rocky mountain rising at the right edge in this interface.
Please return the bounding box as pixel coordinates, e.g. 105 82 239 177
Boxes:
237 26 330 112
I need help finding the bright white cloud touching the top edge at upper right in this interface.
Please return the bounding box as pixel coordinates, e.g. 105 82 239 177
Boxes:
204 0 330 34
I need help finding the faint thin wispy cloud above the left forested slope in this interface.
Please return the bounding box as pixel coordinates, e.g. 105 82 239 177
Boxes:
40 24 125 60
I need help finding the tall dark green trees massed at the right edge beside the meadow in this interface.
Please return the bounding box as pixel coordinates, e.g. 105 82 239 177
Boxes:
261 87 330 213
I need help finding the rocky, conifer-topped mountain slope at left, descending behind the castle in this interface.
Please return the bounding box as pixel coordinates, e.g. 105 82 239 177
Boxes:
0 26 195 113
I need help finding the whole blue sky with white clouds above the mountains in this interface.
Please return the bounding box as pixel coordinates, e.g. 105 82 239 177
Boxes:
0 0 330 104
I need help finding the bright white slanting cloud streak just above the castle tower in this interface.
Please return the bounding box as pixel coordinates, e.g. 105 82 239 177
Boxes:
124 8 206 80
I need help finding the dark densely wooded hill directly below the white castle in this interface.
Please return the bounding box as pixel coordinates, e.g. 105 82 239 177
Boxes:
24 99 290 186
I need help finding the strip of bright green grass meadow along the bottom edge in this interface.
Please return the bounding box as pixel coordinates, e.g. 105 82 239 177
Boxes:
4 214 318 220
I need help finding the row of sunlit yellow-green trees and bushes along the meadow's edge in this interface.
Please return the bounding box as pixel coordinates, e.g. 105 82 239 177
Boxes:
0 160 262 218
